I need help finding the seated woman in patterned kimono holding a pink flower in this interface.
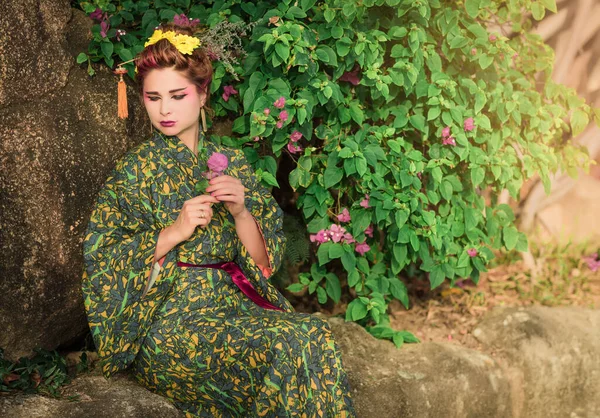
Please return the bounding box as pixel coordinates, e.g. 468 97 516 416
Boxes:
83 24 354 417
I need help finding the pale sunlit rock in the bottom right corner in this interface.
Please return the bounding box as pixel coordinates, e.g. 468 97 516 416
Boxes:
474 306 600 418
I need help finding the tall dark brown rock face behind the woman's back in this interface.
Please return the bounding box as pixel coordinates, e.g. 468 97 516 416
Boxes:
0 0 150 360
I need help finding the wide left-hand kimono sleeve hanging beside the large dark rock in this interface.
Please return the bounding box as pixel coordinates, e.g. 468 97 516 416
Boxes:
82 154 177 377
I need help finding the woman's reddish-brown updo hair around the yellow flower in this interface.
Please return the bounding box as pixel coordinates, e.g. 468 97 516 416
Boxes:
135 23 213 108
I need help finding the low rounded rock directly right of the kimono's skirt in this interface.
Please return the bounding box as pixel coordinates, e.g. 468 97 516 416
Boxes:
329 318 511 418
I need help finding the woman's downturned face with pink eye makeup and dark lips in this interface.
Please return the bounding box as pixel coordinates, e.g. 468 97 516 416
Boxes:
144 68 206 143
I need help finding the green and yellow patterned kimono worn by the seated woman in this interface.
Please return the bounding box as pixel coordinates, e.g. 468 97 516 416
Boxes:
83 131 355 417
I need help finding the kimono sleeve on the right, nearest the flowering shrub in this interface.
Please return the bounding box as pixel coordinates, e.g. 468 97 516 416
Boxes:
236 151 286 279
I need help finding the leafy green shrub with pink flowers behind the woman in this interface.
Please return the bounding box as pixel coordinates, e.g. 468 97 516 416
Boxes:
78 0 592 345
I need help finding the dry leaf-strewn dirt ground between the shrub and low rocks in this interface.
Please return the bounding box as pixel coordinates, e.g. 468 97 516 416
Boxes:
390 255 600 349
